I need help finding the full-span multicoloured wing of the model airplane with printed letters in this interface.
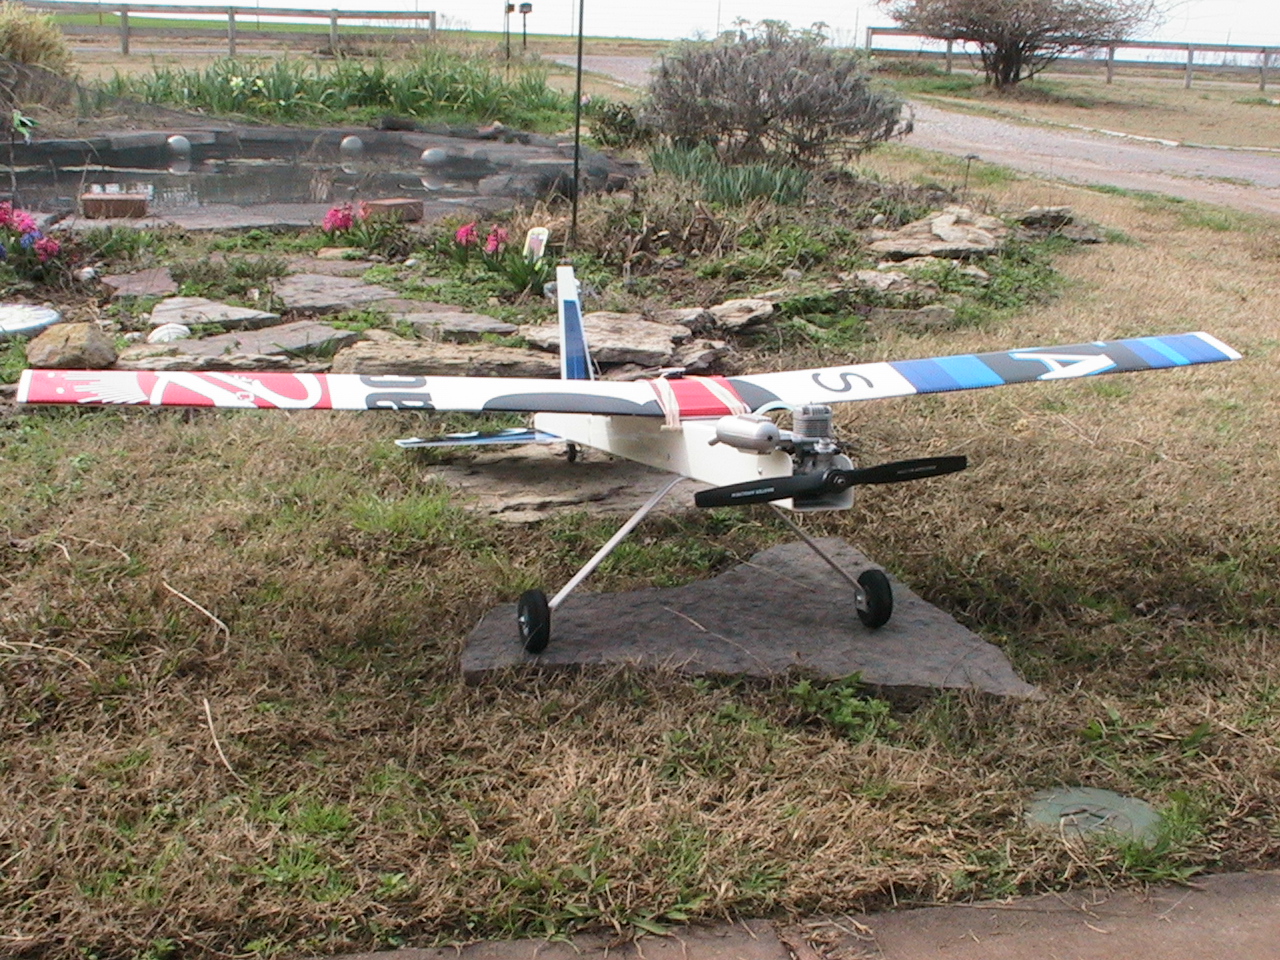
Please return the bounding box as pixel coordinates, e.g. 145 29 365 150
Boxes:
18 333 1240 414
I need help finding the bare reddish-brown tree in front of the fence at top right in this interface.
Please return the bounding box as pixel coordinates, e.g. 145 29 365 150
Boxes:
878 0 1158 90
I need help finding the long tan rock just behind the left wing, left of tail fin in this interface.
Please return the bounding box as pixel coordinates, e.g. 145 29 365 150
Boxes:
332 340 559 378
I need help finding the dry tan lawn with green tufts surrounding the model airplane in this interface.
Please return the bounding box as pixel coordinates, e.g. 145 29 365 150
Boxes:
0 157 1280 960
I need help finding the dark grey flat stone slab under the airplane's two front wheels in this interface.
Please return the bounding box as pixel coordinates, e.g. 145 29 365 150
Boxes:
462 538 1038 698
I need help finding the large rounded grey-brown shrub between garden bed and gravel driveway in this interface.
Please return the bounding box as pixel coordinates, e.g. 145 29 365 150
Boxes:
650 20 909 166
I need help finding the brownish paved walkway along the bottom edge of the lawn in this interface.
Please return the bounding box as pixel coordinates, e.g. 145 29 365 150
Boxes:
327 873 1280 960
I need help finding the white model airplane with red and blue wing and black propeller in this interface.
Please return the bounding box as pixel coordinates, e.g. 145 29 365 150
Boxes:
18 266 1240 653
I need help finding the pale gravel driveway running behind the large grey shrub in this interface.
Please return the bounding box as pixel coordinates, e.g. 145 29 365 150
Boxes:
565 56 1280 216
